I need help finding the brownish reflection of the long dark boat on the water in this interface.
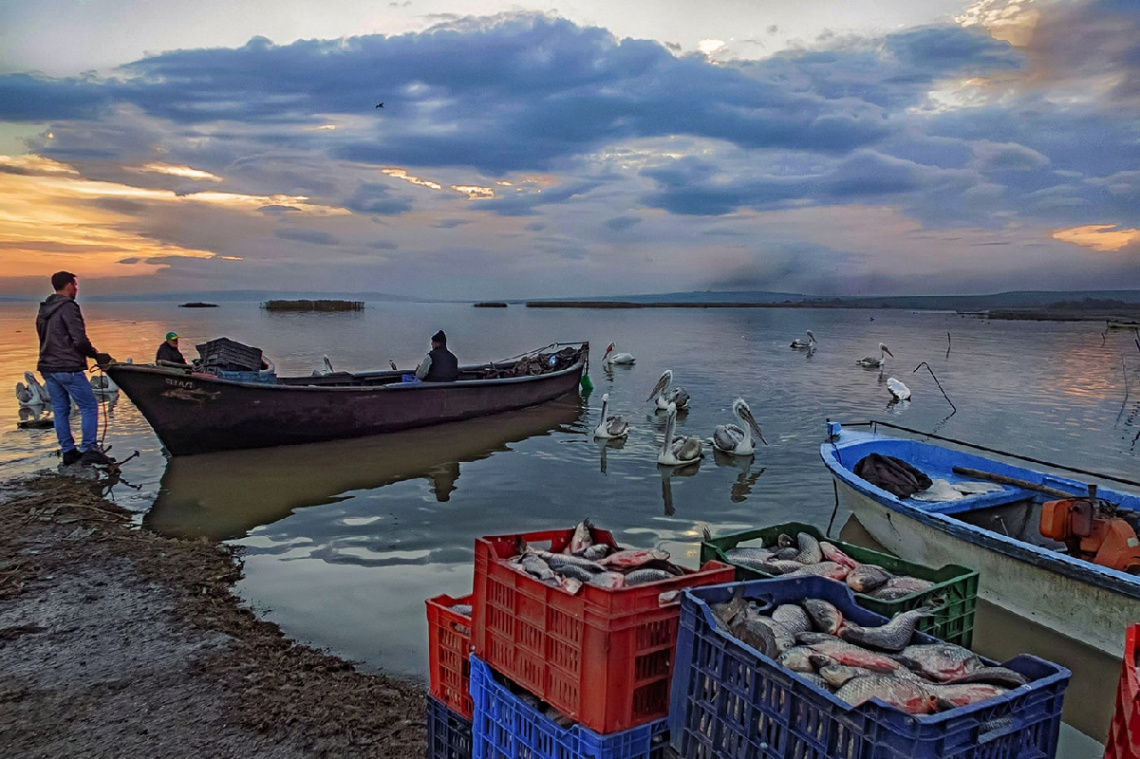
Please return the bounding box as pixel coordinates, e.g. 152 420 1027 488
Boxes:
143 394 583 540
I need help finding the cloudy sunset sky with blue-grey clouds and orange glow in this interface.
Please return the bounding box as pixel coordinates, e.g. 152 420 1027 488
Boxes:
0 0 1140 300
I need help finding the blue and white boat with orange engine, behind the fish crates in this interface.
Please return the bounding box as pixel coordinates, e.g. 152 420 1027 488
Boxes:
820 422 1140 658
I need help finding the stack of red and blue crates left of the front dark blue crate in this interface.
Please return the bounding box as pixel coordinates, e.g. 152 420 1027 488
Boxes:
429 529 734 759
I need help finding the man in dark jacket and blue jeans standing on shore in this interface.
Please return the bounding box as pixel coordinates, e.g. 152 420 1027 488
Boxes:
35 271 114 465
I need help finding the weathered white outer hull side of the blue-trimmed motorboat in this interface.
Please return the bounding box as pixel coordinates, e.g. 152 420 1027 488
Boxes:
838 483 1140 659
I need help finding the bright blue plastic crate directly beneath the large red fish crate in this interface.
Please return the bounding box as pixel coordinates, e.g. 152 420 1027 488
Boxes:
471 654 668 759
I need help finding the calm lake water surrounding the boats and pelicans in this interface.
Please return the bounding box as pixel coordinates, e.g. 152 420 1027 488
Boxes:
0 303 1140 757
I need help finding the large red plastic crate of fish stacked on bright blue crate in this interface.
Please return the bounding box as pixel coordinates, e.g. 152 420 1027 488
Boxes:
473 529 735 735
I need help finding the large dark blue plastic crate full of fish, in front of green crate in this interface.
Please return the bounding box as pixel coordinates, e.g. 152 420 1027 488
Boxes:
669 577 1069 759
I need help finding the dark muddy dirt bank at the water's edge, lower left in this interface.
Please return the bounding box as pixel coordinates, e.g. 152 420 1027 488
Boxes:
0 474 425 759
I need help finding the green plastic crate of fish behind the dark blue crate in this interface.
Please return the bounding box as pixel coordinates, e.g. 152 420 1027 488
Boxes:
701 522 978 647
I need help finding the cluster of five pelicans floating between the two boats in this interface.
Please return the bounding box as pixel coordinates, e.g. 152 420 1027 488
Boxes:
594 343 768 467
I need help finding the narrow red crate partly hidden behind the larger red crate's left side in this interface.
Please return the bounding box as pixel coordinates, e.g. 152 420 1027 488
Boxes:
425 595 473 720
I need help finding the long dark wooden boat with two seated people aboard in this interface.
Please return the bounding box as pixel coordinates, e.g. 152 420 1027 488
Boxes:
107 342 589 456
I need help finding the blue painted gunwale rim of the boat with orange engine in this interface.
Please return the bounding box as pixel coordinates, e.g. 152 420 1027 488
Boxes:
820 430 1140 598
